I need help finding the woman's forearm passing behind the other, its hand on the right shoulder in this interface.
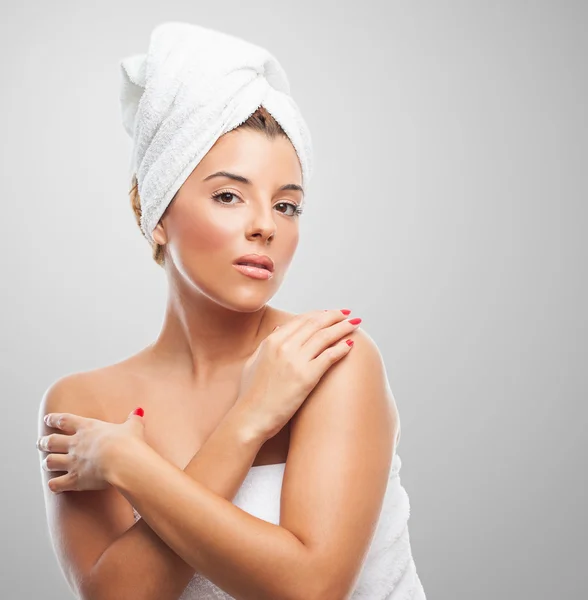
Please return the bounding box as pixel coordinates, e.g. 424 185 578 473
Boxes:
84 411 263 600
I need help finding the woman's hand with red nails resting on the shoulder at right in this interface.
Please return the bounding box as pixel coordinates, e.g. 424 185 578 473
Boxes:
235 310 358 440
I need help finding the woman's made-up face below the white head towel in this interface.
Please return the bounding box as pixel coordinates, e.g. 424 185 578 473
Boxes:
153 129 304 311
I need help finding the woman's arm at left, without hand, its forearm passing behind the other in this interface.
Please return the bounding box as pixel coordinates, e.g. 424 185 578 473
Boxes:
38 374 265 600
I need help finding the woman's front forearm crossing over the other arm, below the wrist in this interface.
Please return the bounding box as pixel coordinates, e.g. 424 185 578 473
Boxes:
107 441 318 600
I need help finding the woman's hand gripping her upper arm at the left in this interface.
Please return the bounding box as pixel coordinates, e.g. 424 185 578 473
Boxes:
37 411 145 493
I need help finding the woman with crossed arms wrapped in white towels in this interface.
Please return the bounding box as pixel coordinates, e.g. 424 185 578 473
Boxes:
37 24 425 600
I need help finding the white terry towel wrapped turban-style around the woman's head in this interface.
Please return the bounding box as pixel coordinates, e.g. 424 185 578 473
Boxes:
120 21 313 242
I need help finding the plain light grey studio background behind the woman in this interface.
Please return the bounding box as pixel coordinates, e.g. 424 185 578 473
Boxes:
0 0 588 600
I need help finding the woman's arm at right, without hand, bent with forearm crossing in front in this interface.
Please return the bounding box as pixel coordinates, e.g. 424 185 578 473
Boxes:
105 330 398 600
